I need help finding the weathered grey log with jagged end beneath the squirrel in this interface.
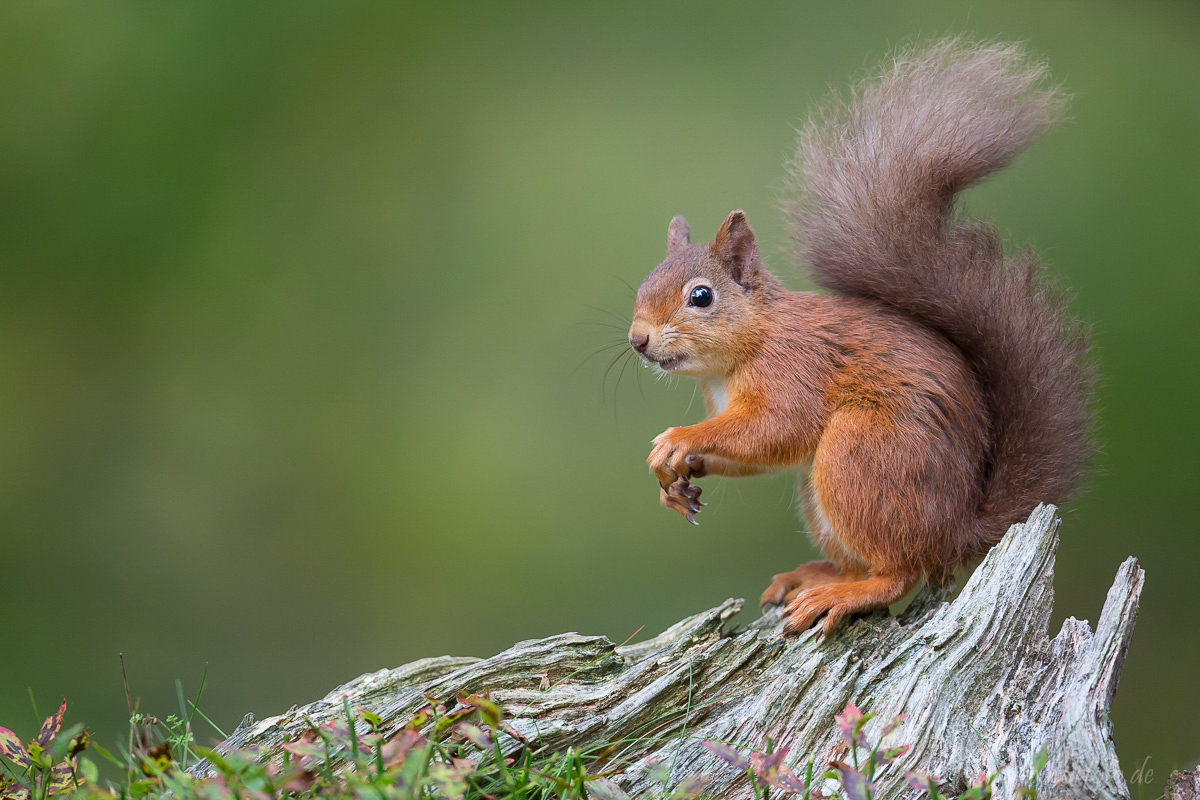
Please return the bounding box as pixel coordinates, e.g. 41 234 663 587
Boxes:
196 506 1144 798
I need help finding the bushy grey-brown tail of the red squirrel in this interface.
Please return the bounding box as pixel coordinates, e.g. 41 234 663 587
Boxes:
786 38 1093 552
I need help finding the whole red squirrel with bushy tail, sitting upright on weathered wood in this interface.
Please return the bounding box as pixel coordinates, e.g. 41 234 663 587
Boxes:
629 38 1094 636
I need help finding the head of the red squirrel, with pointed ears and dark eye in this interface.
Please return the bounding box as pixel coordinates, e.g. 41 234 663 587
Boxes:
629 210 780 378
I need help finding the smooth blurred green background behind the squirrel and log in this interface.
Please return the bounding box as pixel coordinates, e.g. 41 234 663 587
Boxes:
0 0 1200 792
